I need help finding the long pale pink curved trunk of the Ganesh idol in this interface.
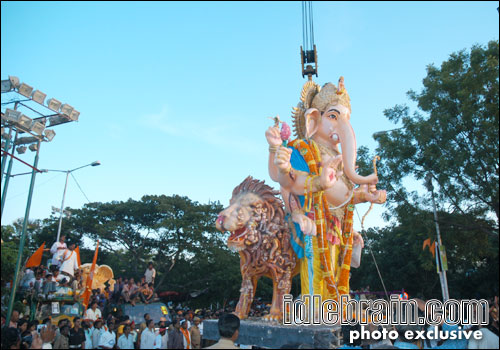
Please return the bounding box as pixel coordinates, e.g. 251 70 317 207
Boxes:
338 120 378 185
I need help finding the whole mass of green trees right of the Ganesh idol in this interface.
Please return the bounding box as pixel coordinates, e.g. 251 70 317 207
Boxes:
353 41 499 297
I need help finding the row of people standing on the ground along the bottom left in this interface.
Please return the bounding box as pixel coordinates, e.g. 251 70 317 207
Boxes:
2 309 239 349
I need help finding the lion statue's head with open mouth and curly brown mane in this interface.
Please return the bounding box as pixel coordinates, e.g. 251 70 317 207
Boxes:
215 176 284 251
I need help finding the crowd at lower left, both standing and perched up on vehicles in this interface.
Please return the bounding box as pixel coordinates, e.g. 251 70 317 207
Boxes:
2 235 246 349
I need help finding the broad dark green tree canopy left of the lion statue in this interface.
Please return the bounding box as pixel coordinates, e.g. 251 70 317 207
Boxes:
55 195 245 303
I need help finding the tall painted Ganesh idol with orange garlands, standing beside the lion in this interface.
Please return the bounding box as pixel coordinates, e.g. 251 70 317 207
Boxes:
265 77 386 301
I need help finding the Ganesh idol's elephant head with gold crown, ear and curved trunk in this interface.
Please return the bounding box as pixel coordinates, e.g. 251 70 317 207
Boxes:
293 77 378 185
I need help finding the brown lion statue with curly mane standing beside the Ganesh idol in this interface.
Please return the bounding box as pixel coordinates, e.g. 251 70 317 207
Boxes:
216 176 298 321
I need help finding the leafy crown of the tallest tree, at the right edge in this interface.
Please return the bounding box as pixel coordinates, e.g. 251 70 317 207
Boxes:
376 41 499 226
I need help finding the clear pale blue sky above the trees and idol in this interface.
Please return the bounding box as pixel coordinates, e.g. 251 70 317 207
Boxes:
1 1 498 237
